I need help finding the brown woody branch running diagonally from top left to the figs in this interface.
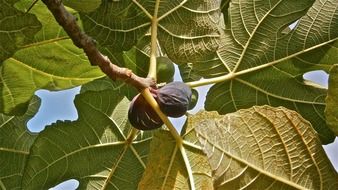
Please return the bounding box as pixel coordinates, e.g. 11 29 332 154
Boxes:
42 0 155 91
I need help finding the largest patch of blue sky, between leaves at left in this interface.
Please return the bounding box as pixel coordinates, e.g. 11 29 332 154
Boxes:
27 87 80 132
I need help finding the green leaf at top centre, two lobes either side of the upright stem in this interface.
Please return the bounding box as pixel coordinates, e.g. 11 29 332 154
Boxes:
81 0 220 63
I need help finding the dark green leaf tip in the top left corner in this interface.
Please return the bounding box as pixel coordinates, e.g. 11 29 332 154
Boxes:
0 0 41 63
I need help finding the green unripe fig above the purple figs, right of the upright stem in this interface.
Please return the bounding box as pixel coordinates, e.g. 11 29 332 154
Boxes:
156 57 175 83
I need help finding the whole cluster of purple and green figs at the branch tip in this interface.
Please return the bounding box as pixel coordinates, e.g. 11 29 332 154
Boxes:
128 58 198 130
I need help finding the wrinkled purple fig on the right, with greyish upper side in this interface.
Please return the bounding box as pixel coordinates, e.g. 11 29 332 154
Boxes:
155 82 192 117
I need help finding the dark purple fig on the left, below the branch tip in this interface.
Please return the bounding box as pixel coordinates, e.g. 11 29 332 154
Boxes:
128 94 163 130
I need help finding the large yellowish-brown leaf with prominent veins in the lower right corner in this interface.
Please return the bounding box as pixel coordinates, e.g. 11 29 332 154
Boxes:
187 106 338 190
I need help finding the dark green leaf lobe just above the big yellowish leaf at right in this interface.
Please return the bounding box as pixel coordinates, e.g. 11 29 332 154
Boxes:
205 64 335 144
